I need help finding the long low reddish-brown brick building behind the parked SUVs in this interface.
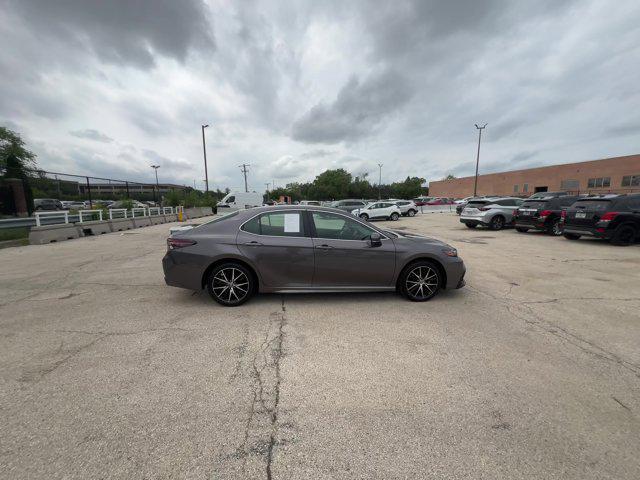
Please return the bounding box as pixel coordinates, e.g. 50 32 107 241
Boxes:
429 155 640 198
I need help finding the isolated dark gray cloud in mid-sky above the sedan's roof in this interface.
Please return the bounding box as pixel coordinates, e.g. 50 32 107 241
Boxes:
292 71 412 144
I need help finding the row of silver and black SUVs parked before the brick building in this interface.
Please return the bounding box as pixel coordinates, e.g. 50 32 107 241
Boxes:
460 192 640 245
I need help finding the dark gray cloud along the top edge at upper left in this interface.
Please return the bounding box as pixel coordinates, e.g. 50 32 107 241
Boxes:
8 0 215 68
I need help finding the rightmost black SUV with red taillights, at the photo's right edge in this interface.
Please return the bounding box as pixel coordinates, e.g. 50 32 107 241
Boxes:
563 194 640 245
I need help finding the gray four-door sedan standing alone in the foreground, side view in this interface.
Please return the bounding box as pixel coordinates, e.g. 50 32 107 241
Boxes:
162 206 465 306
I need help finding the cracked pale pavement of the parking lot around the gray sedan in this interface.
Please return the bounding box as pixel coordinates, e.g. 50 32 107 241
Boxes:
0 214 640 480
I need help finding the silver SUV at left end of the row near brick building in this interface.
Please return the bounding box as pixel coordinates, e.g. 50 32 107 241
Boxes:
460 197 523 230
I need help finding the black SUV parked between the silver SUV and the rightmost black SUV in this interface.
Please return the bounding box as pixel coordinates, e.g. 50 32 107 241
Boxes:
515 195 580 236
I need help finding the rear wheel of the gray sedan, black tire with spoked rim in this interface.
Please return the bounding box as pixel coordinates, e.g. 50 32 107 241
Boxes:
207 262 256 307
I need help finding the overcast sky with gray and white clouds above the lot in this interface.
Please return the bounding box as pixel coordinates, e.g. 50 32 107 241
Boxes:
0 0 640 191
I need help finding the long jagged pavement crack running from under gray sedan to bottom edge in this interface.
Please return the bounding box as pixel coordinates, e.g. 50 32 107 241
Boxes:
235 298 286 480
